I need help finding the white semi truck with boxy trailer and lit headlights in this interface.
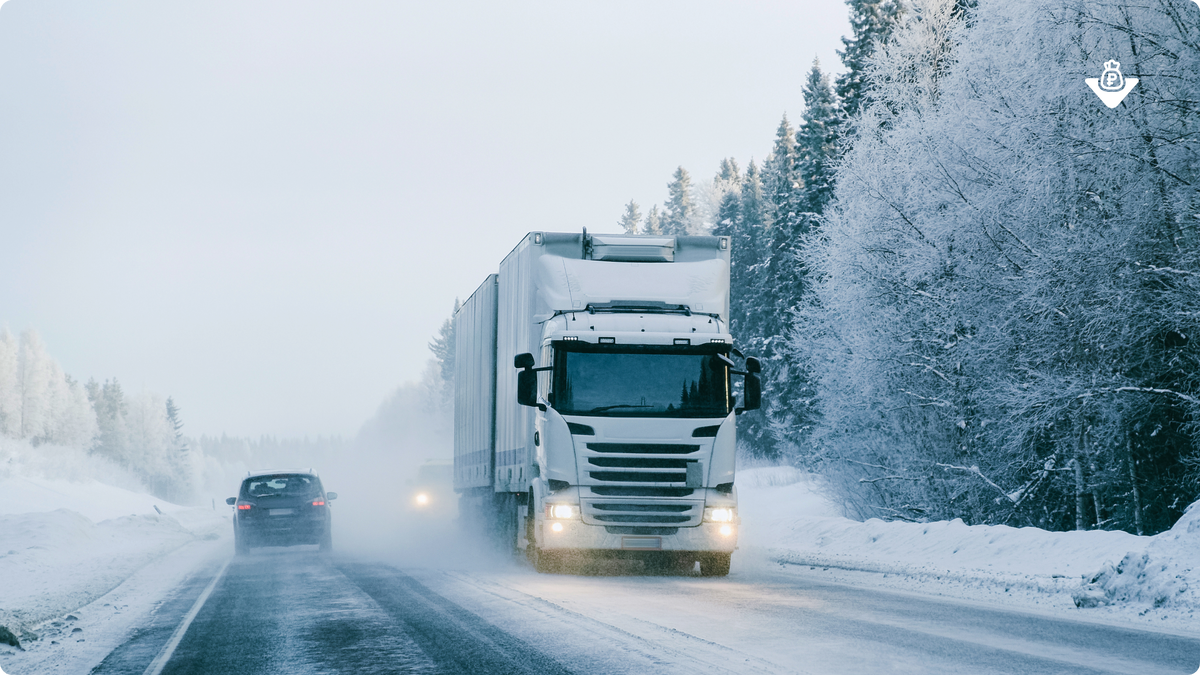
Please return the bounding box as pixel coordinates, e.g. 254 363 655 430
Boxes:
454 231 761 575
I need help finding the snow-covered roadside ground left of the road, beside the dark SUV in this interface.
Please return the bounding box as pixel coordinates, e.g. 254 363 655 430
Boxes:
0 473 229 669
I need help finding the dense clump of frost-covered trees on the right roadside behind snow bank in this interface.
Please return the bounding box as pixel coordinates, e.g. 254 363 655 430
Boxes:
794 0 1200 532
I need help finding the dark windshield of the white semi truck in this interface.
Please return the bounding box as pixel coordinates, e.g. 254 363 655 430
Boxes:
552 342 730 417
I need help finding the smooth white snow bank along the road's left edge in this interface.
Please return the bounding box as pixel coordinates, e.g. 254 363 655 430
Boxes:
0 474 228 641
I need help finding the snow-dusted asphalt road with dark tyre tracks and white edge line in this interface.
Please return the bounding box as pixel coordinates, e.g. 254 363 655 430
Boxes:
84 549 1200 675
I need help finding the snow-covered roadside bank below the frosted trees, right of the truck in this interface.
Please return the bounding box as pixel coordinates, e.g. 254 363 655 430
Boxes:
734 467 1200 632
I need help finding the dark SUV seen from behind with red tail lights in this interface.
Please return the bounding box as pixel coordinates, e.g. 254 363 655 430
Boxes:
226 470 337 555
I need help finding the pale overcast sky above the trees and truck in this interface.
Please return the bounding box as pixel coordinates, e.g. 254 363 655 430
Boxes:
0 0 850 436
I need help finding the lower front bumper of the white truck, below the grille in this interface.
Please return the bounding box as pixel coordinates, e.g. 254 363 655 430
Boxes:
536 519 738 552
